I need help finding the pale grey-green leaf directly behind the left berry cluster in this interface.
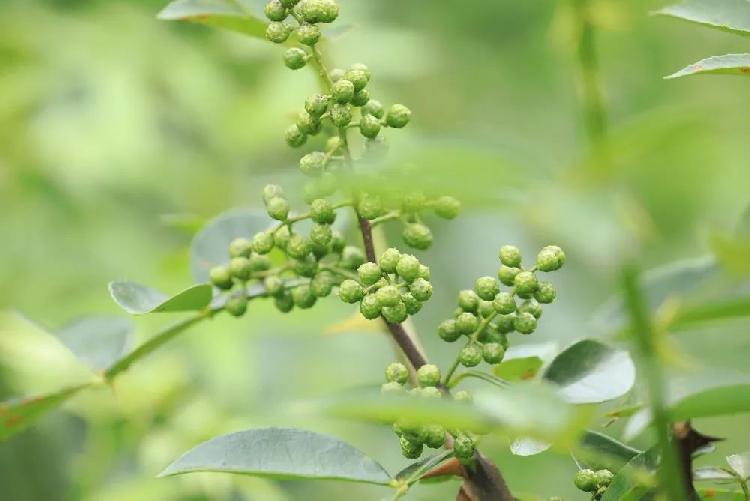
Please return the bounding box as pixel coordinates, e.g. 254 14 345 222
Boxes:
190 209 270 282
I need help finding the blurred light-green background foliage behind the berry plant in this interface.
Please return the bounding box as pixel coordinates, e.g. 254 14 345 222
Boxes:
0 0 750 501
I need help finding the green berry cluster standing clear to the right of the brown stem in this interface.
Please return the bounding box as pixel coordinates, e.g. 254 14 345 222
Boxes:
438 245 565 367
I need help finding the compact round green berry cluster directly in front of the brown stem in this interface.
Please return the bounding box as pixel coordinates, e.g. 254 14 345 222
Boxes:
339 248 432 324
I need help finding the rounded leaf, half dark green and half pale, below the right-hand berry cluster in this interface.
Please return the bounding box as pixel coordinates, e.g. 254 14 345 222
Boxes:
542 339 635 404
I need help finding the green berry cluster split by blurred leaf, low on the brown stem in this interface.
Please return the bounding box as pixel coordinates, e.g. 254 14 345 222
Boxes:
382 362 477 464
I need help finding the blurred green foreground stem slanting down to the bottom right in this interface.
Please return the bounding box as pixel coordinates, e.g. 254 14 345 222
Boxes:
623 266 692 501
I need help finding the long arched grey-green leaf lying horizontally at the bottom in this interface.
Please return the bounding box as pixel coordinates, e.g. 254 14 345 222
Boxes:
160 428 391 485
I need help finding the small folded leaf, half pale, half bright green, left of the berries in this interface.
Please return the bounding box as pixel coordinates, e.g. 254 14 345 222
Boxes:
109 282 213 315
